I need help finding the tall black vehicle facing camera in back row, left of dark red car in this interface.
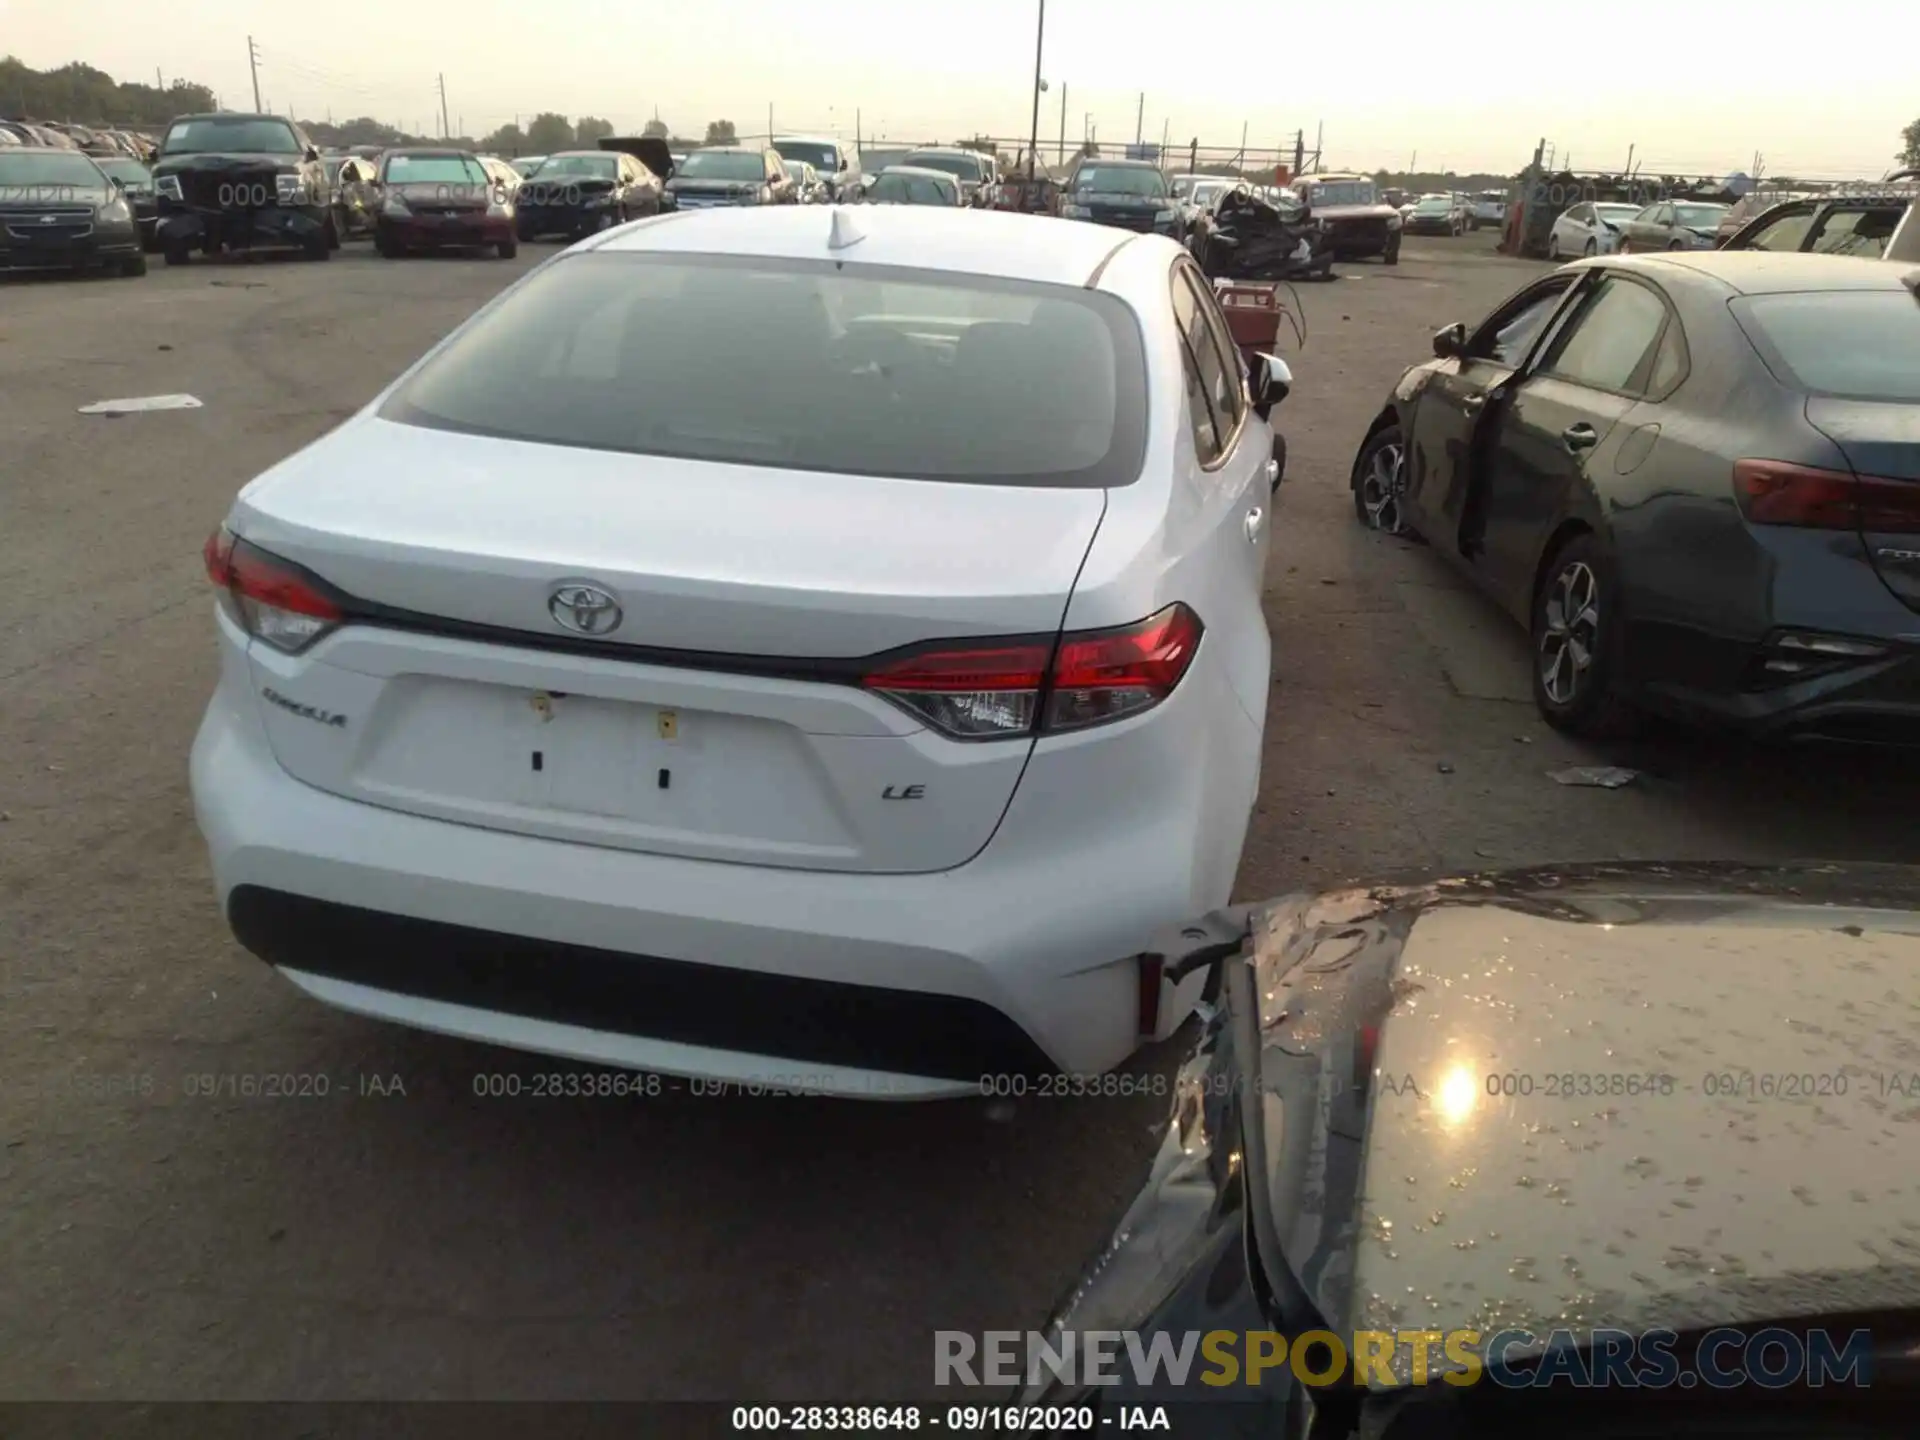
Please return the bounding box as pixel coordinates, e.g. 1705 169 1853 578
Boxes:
154 113 340 265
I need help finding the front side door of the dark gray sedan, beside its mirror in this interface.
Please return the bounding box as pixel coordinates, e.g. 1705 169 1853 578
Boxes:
1404 275 1578 553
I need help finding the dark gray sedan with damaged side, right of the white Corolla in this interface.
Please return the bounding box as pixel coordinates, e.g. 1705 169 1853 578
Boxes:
1352 252 1920 743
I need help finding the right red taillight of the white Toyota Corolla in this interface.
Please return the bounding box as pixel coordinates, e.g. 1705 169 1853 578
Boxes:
860 605 1202 739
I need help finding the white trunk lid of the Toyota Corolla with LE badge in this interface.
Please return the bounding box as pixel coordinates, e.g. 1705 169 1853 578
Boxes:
232 417 1104 872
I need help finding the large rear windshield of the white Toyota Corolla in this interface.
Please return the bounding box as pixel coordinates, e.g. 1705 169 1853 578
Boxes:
382 253 1146 488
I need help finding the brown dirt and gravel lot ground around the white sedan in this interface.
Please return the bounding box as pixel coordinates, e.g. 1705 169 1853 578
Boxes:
0 236 1920 1400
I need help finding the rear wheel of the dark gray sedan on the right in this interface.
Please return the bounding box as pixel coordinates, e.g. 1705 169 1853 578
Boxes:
1528 534 1632 739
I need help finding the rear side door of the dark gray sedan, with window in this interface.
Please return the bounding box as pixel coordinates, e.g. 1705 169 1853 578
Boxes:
1475 271 1678 618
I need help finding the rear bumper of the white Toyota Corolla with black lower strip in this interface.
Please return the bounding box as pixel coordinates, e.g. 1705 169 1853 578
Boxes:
192 629 1260 1096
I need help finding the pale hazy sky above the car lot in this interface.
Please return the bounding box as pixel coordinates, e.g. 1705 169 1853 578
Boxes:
0 0 1920 177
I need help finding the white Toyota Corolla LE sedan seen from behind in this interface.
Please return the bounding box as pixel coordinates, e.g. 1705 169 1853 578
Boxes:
192 205 1288 1096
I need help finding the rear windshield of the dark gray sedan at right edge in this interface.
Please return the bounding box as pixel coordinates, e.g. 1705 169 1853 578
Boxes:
1734 290 1920 403
